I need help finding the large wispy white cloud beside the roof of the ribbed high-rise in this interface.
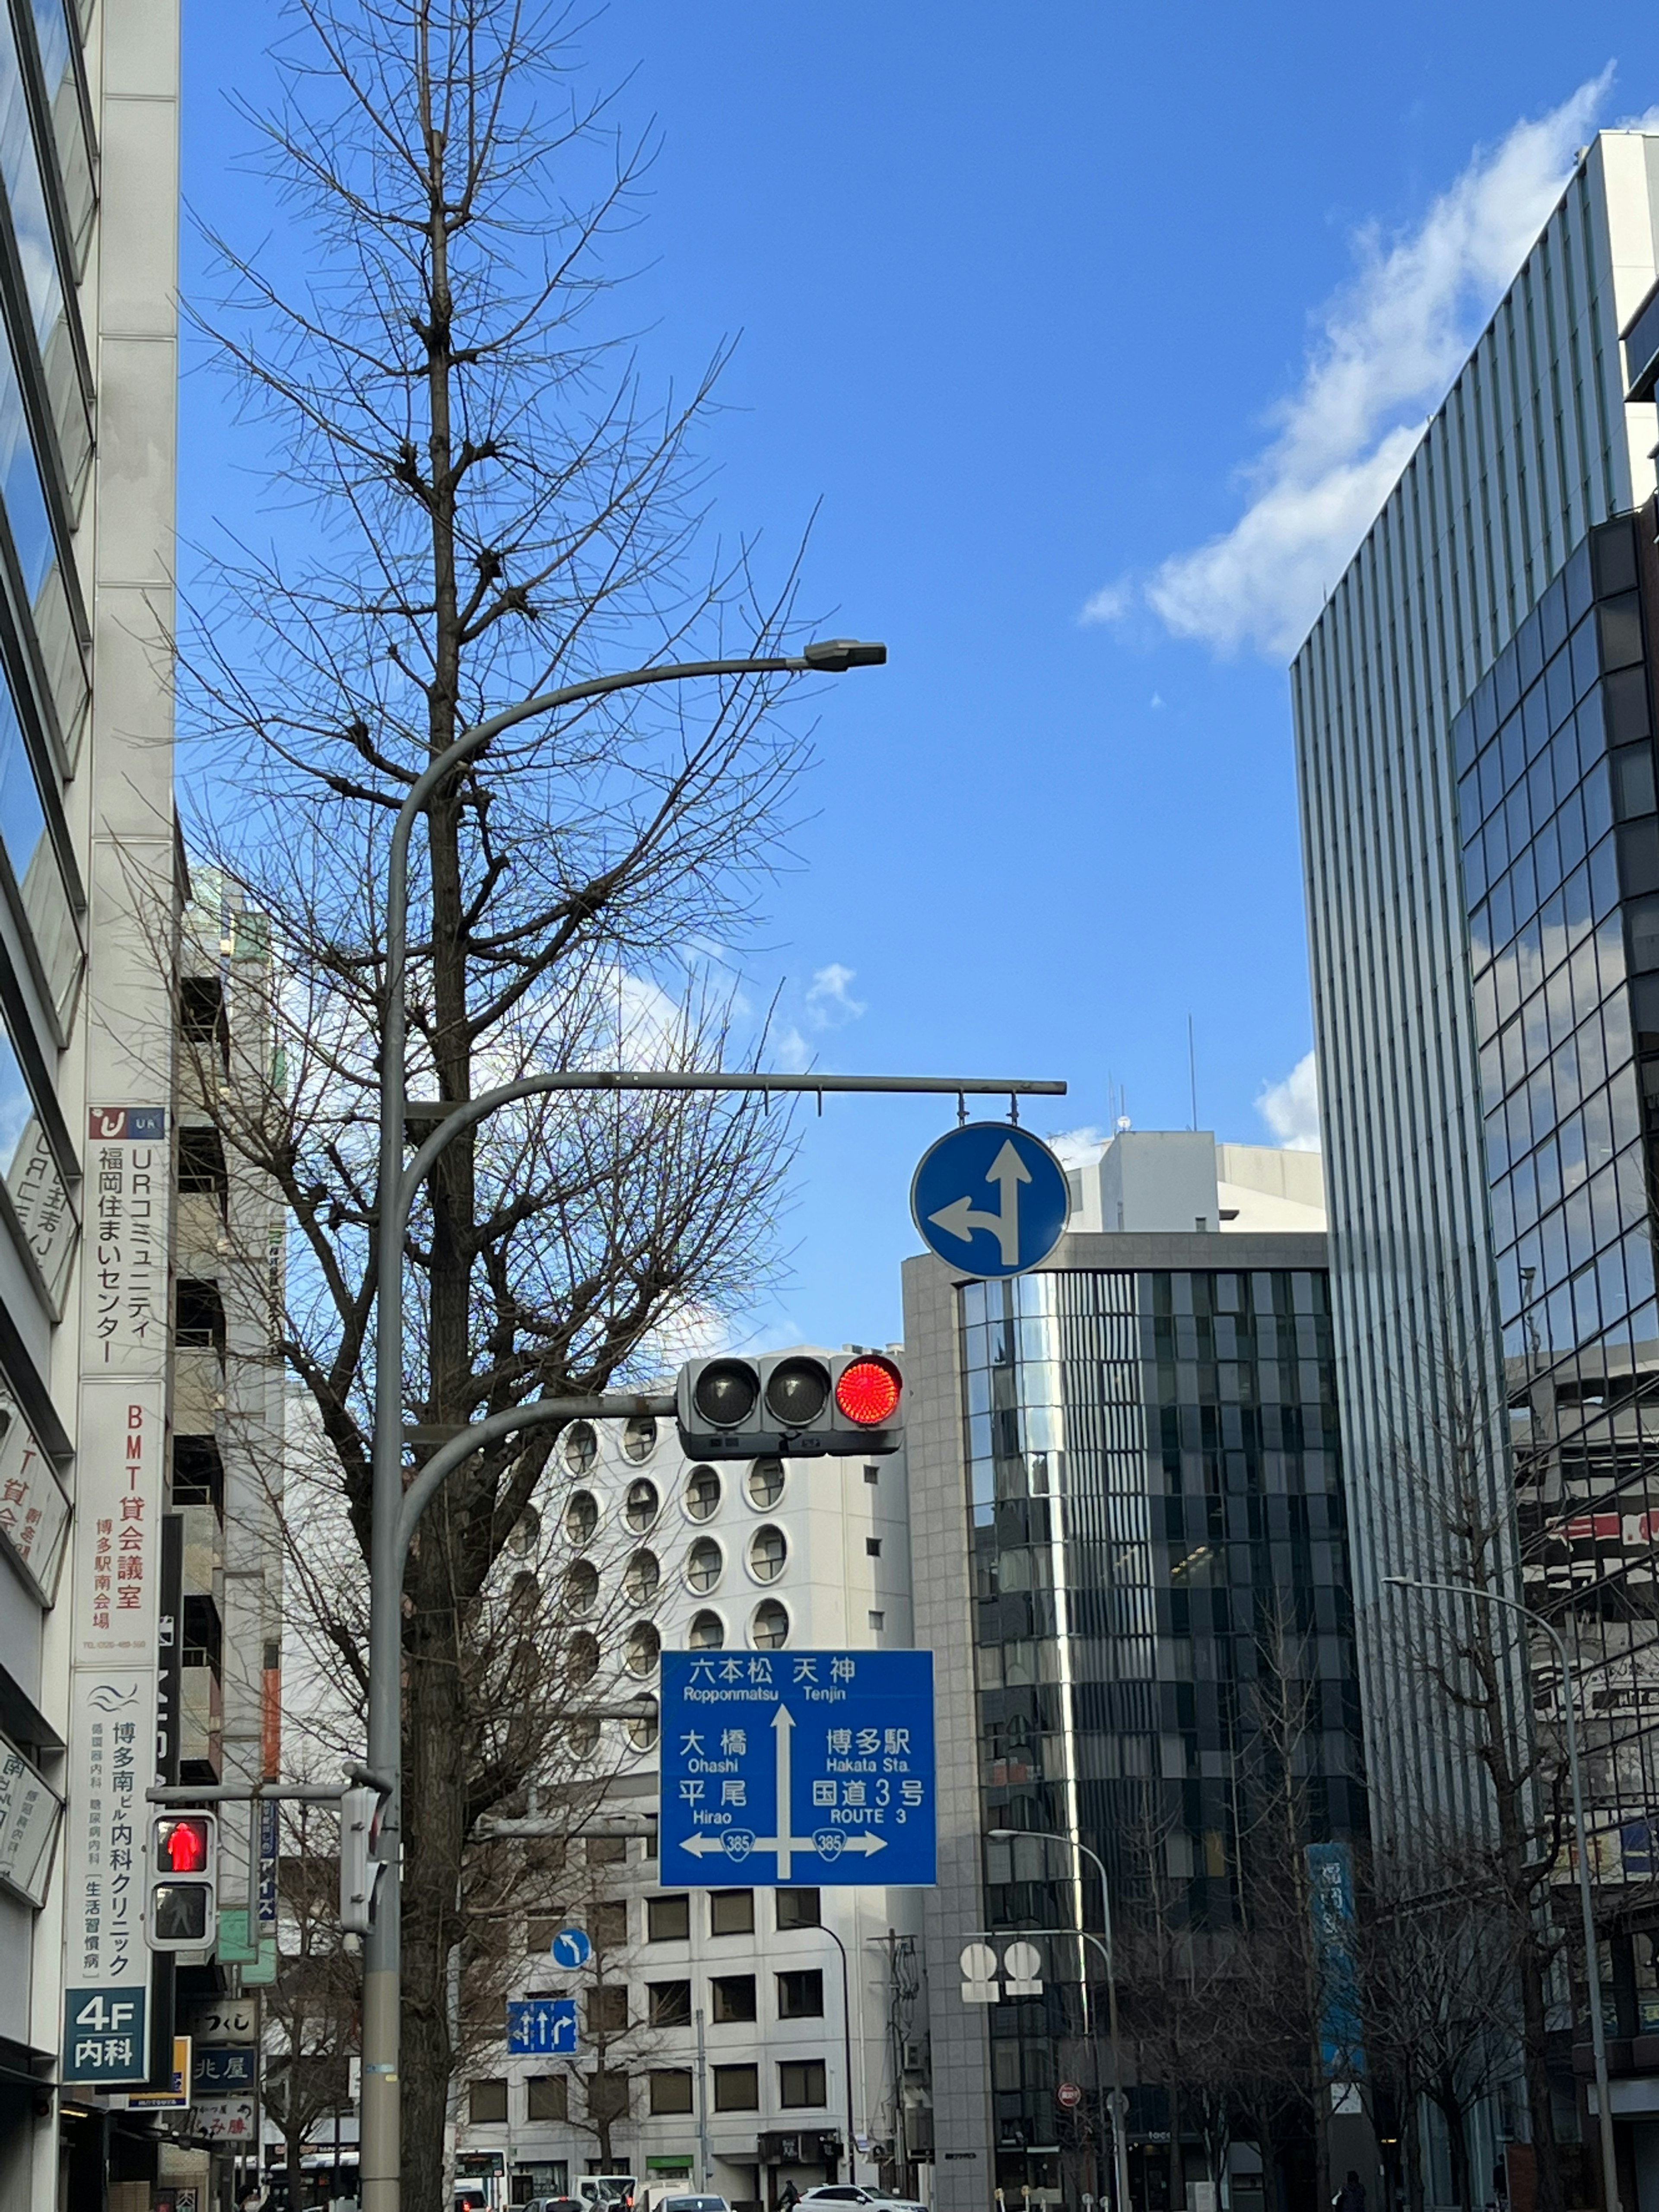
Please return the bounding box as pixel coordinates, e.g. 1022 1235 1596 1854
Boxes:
1084 67 1612 659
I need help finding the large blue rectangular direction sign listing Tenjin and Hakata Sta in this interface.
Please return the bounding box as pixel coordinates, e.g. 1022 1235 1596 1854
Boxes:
659 1653 934 1889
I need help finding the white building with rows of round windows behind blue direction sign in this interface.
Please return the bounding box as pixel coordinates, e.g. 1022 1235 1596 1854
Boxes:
456 1380 931 2212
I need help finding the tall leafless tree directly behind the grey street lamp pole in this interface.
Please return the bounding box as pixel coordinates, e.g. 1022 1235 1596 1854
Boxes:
184 0 823 2203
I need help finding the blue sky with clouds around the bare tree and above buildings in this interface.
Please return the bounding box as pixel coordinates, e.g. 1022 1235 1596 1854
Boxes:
181 0 1659 1343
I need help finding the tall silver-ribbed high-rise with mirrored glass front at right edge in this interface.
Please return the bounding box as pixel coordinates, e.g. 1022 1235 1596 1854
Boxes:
1292 130 1659 2194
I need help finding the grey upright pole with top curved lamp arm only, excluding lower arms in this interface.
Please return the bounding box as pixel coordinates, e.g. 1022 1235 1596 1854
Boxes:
361 639 887 2212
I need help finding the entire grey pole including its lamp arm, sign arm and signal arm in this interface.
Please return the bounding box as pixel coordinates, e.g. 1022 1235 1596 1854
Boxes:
358 639 1066 2212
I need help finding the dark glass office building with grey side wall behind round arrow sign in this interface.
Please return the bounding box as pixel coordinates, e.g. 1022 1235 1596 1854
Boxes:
905 1132 1365 2212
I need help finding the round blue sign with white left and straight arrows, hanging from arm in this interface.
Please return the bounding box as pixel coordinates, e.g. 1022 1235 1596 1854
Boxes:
909 1122 1071 1276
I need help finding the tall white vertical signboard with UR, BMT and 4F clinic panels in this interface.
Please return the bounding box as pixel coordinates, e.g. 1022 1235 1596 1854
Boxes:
62 1106 170 2088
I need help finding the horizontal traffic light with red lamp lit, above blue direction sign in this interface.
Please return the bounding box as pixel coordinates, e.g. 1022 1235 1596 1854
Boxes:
675 1351 905 1460
